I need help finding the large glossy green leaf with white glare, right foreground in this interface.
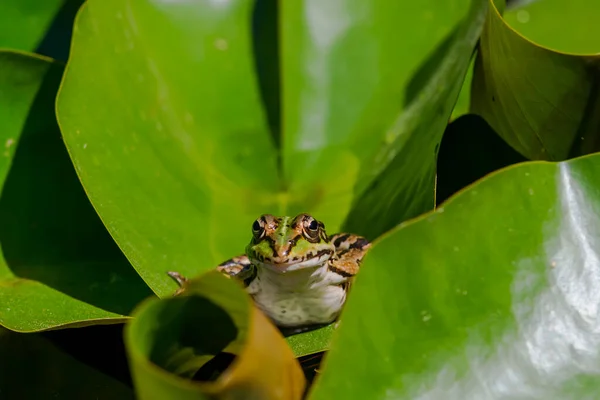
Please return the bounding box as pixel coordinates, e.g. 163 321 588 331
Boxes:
311 155 600 399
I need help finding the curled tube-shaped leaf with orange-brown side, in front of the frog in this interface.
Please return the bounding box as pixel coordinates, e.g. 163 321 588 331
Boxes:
125 271 305 399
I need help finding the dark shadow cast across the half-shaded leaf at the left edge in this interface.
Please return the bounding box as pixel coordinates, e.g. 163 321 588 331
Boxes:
0 64 152 315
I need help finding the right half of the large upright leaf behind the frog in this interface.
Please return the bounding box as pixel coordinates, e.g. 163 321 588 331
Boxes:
281 0 486 237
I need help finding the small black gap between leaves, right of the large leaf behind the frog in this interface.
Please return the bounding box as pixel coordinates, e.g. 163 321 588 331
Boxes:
436 114 527 205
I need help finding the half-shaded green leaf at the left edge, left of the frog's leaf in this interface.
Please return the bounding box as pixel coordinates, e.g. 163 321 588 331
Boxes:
0 51 151 331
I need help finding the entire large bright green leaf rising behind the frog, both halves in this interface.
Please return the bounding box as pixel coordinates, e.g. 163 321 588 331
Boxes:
58 0 486 351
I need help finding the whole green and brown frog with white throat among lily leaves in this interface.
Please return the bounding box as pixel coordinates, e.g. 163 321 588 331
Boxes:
168 213 371 329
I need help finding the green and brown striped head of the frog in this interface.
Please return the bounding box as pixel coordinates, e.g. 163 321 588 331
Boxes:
246 214 335 272
